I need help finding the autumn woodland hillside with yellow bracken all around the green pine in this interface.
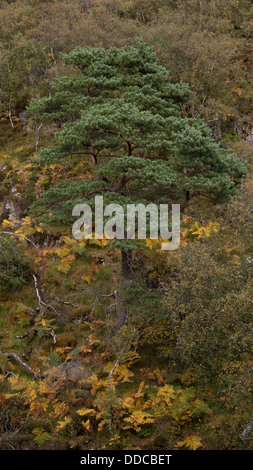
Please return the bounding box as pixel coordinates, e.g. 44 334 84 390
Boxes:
0 0 253 450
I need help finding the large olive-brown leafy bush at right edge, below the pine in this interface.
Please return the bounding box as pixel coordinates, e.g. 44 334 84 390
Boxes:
165 240 253 400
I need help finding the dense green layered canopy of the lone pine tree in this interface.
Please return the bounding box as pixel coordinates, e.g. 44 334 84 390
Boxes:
29 42 245 223
